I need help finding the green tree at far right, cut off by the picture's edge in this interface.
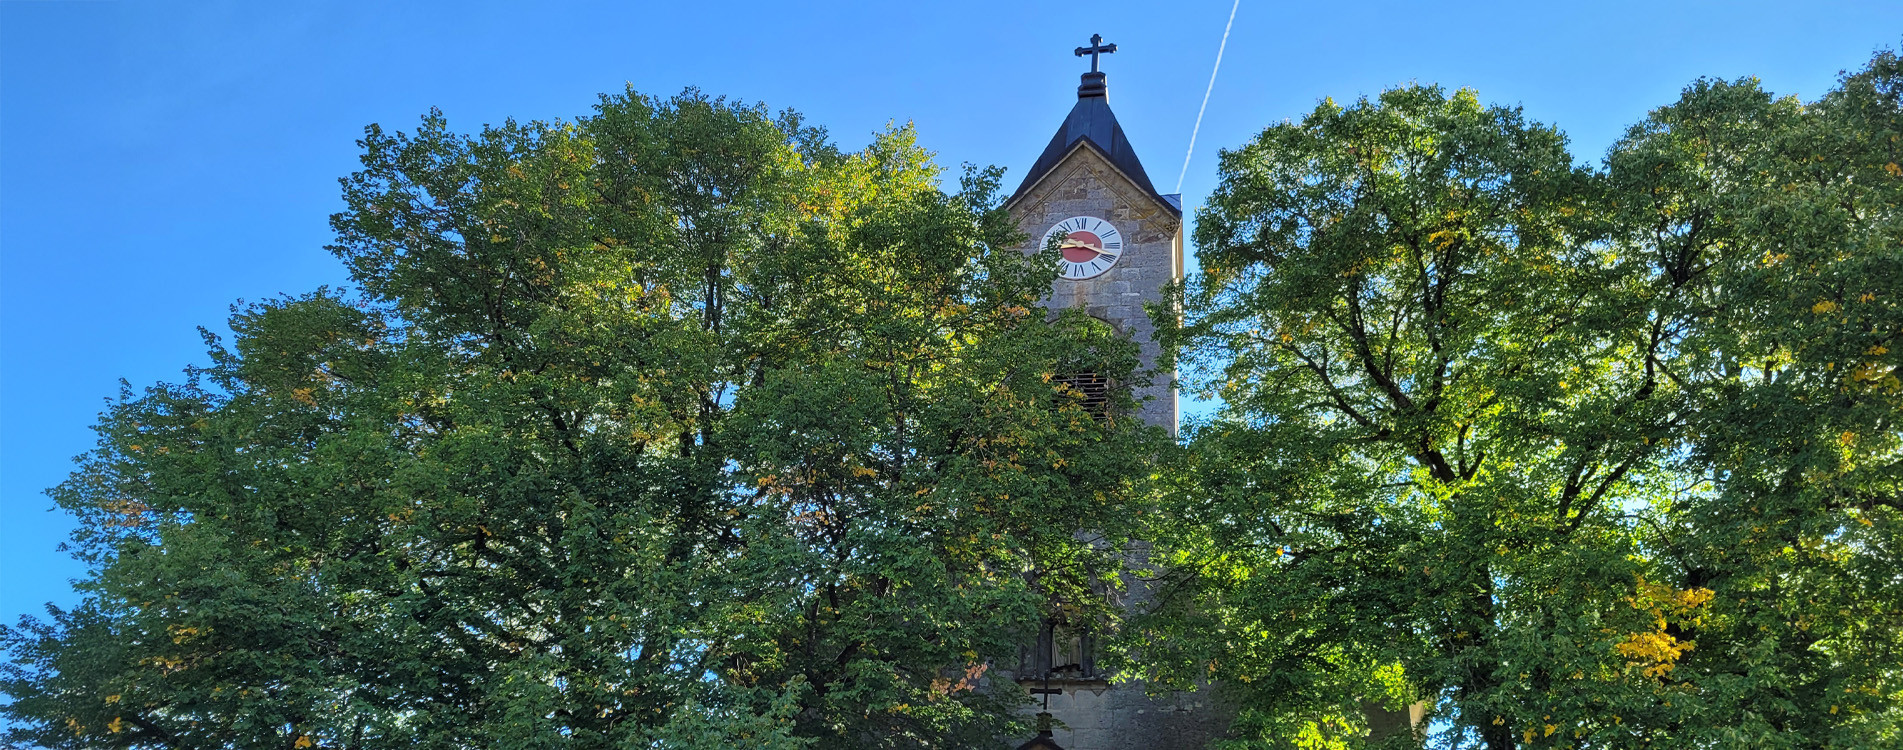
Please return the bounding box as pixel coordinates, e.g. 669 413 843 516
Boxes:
1608 53 1903 748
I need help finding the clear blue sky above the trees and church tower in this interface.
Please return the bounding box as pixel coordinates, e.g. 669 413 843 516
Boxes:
0 0 1903 622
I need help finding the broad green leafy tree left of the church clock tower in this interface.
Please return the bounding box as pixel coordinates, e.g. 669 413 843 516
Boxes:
0 91 1157 750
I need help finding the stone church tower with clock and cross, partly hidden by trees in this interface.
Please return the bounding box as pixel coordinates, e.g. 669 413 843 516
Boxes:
1005 36 1227 750
